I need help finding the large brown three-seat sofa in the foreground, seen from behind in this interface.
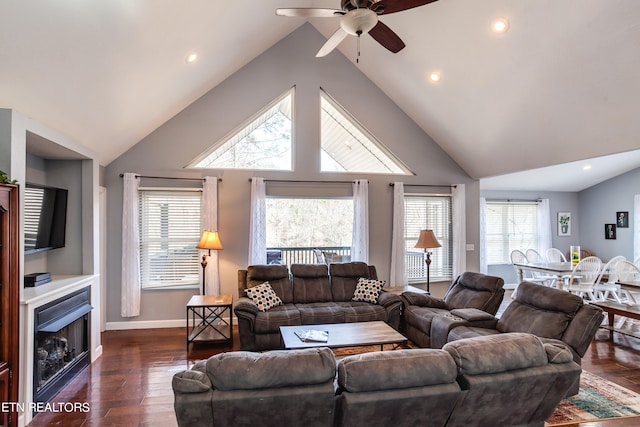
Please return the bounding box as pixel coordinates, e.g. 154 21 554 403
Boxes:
172 333 581 427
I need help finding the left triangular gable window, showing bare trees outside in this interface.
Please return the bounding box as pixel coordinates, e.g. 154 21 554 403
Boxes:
187 88 295 170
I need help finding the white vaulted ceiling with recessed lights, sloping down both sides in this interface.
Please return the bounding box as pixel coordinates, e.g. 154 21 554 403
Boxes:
0 0 640 190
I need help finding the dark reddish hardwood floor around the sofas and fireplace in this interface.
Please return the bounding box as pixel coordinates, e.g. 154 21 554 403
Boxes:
29 296 640 427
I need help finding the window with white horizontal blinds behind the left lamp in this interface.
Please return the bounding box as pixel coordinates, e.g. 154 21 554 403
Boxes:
139 190 201 289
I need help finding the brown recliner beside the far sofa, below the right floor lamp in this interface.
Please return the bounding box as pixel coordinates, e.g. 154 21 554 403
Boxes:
402 272 504 348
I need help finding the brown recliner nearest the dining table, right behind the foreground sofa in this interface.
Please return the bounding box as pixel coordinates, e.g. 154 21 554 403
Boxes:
447 282 604 396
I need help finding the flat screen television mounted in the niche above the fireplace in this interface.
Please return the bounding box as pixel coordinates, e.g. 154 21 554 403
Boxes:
24 183 68 253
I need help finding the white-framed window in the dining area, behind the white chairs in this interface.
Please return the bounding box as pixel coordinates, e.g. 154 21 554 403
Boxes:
485 200 538 264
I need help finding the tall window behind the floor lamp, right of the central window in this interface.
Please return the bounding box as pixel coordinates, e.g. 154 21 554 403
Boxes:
404 195 453 282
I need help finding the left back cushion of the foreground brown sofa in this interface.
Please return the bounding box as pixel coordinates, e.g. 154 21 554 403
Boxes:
207 347 336 392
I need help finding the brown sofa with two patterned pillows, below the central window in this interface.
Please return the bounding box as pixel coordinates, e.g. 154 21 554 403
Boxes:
234 262 402 350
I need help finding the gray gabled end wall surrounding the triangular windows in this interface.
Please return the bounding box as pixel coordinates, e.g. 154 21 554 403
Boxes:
103 24 479 327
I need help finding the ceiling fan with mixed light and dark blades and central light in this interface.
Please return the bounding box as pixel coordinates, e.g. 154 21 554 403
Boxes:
276 0 437 57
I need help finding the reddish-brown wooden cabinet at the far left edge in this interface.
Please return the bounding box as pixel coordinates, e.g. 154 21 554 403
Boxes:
0 184 20 427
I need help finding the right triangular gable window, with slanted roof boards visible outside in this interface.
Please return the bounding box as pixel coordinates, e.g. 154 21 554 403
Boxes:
320 90 413 175
